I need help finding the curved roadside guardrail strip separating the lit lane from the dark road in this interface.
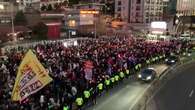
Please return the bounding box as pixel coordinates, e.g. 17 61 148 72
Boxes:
132 53 195 110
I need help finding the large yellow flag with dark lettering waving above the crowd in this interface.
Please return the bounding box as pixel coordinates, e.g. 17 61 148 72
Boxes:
11 50 53 101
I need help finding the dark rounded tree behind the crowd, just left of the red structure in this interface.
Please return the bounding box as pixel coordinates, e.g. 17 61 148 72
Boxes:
32 22 48 40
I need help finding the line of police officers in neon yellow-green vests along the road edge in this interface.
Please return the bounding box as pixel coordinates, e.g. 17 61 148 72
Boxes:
63 54 166 110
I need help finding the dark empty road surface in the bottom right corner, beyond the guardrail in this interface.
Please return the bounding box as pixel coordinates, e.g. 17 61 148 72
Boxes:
145 63 195 110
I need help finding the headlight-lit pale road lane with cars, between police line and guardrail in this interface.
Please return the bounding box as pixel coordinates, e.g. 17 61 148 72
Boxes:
85 64 168 110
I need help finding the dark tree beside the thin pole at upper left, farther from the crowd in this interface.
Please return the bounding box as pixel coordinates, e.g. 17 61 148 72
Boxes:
14 11 27 25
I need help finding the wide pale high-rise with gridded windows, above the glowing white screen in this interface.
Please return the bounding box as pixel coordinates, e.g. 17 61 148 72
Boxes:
115 0 167 24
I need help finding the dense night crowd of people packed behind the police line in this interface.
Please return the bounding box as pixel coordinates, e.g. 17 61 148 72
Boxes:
0 37 190 110
